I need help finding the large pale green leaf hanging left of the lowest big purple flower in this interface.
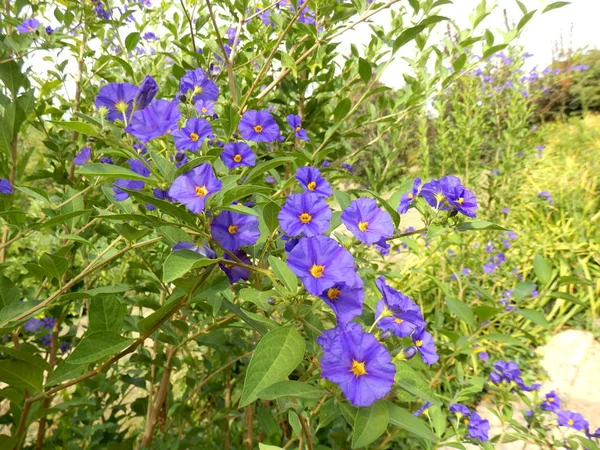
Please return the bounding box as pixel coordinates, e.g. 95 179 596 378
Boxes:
239 326 306 408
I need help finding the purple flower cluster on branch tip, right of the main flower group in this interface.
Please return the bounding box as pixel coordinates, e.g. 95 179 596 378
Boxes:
398 175 477 217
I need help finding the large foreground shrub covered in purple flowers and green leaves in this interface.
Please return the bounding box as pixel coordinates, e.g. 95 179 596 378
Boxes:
0 0 598 450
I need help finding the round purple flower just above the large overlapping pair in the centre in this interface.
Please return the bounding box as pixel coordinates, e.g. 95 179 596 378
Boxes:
277 194 331 237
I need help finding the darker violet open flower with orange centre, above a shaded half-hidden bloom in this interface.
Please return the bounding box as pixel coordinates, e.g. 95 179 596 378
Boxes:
210 211 260 252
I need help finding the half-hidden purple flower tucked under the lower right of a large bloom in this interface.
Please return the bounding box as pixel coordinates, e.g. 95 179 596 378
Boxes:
319 273 365 323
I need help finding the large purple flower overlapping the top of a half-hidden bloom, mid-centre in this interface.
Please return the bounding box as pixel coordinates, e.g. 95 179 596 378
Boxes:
287 236 355 295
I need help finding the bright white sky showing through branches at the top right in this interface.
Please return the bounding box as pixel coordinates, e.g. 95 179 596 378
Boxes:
340 0 600 87
